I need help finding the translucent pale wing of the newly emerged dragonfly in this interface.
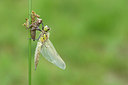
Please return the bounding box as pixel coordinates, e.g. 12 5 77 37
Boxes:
41 39 66 69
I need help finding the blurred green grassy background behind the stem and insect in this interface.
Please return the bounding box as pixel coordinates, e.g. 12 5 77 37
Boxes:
0 0 128 85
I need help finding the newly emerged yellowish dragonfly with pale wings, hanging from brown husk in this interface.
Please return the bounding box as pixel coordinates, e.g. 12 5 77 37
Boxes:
34 25 66 70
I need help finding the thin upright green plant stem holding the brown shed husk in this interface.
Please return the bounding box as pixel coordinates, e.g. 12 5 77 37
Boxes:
28 0 32 85
